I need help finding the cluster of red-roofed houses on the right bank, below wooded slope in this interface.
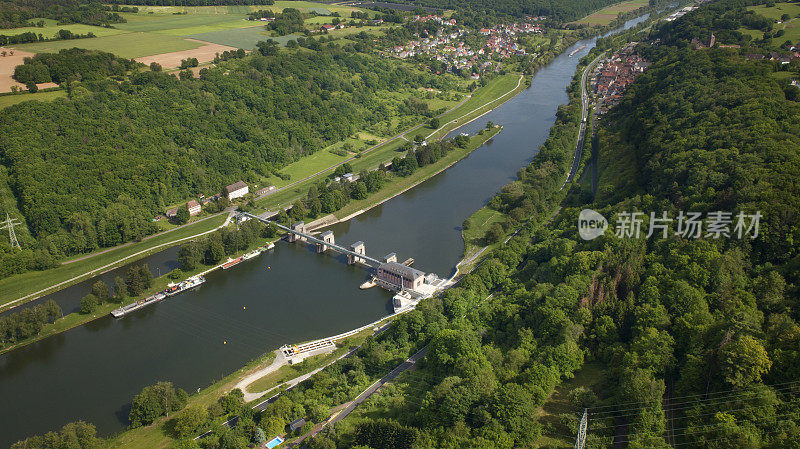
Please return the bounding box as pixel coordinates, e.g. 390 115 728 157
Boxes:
591 42 650 114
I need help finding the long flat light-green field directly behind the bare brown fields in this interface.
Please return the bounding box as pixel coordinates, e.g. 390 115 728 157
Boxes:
9 33 203 58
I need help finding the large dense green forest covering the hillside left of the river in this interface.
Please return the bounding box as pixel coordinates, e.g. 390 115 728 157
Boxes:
0 43 457 275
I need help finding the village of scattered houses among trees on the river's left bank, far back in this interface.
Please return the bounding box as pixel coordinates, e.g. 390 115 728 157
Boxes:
387 20 543 79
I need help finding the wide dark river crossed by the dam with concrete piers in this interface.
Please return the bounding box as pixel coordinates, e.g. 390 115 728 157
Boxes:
0 14 644 447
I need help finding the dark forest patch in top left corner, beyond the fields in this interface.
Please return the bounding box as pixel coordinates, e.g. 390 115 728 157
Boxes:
0 0 125 28
